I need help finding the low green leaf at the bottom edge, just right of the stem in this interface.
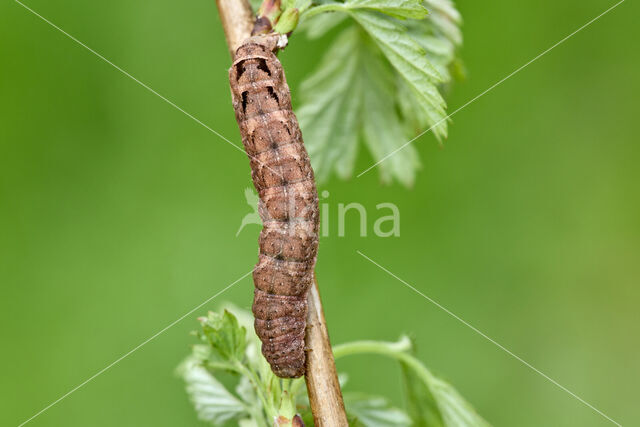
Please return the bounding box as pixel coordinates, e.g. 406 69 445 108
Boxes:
344 393 411 427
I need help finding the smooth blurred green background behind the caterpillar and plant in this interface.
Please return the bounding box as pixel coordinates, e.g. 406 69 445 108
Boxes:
0 0 640 426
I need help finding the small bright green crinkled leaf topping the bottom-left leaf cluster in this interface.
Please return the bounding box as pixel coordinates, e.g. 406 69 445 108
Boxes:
199 310 247 362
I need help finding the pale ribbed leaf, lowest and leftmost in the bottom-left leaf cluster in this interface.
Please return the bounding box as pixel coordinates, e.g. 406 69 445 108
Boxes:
179 359 248 425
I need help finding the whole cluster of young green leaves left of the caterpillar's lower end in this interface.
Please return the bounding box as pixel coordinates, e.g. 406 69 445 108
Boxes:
178 310 314 427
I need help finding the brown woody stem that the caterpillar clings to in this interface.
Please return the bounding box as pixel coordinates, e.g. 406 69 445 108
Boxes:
216 0 348 427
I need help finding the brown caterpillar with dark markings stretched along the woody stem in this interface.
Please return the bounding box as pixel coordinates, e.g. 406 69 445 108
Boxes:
229 35 318 378
